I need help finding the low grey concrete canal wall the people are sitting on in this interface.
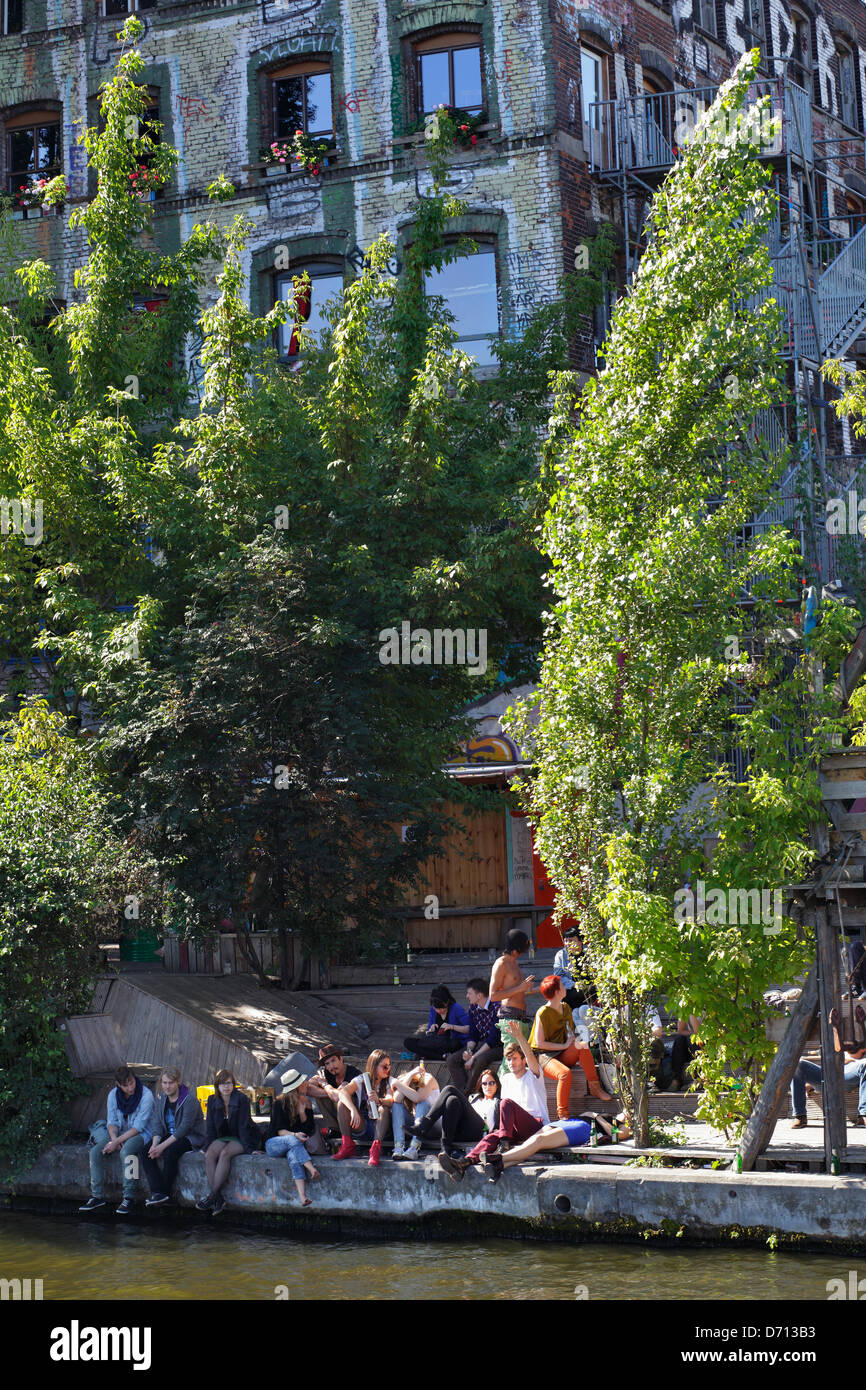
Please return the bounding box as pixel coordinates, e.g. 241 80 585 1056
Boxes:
0 1144 866 1252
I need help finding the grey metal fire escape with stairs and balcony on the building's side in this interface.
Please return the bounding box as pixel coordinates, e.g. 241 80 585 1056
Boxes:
585 69 866 584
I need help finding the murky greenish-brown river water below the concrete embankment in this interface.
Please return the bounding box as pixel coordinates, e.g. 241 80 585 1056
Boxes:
0 1212 866 1302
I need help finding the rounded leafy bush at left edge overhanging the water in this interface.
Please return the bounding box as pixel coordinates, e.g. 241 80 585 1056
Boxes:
0 702 164 1176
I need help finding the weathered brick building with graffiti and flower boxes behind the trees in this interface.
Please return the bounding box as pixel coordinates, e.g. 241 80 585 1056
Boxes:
0 0 866 522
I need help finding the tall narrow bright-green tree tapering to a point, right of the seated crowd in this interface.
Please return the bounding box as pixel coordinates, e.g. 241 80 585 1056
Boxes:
513 51 838 1143
